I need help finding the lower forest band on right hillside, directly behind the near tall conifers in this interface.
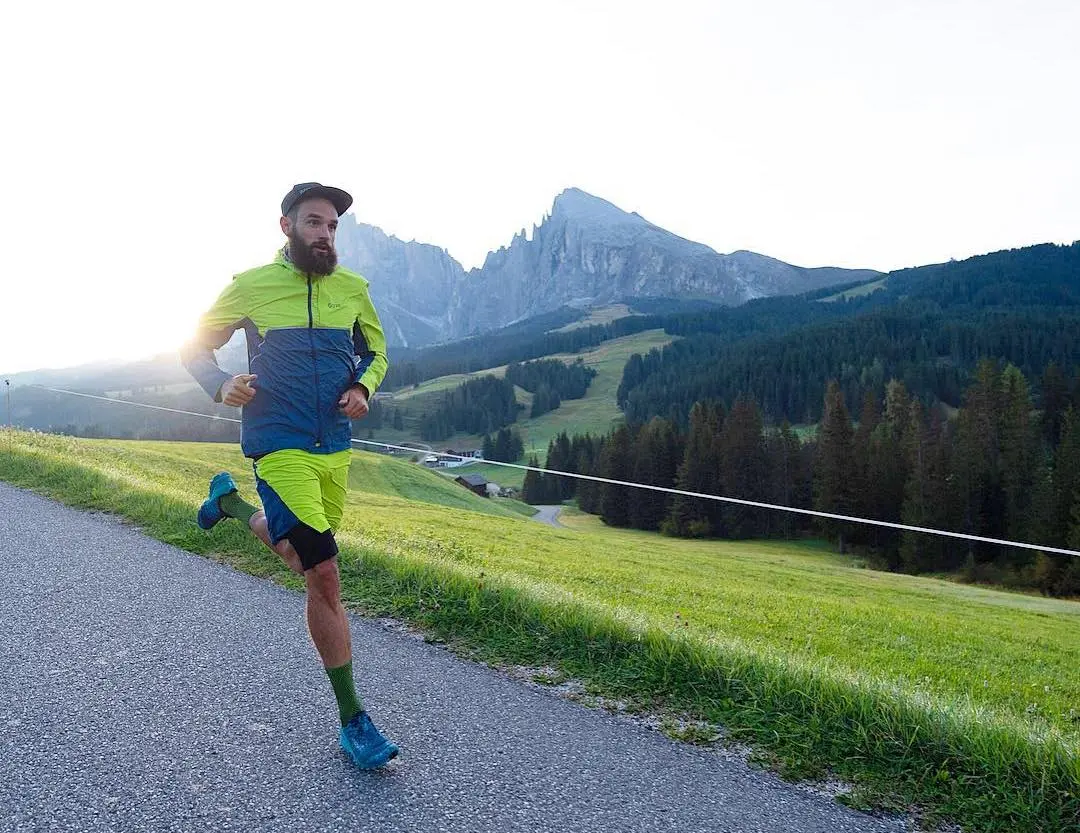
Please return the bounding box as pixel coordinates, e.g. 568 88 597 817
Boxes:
617 305 1080 425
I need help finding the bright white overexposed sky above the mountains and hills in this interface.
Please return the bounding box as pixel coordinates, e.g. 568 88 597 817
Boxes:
0 0 1080 372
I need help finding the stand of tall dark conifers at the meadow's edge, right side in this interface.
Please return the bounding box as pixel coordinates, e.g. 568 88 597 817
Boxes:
523 360 1080 595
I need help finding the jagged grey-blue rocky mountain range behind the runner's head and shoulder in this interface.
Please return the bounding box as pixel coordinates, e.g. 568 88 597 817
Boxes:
337 188 880 347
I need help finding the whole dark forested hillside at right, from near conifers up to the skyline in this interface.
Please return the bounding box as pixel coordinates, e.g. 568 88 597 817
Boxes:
617 243 1080 428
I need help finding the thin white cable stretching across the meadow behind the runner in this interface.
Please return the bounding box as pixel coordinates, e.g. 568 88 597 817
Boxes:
27 386 1080 557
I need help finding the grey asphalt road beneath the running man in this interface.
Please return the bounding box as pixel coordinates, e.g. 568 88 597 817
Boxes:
0 484 905 833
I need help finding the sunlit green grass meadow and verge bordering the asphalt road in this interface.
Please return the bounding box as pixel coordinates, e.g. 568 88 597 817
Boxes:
0 431 1080 831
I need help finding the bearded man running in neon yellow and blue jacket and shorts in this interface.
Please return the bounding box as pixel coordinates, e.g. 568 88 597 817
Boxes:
181 183 397 769
